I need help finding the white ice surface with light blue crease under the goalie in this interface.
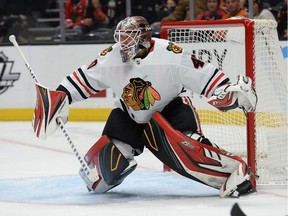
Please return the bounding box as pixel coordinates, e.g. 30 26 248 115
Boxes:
0 122 287 216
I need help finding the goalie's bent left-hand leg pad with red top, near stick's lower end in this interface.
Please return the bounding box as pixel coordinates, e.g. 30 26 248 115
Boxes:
80 136 137 193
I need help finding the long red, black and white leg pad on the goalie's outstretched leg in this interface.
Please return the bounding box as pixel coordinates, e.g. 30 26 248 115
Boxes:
143 113 251 189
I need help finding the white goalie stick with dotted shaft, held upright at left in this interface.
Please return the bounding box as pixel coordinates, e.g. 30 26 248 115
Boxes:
9 35 98 186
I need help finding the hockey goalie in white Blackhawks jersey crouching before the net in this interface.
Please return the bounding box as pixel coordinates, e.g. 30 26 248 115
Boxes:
33 16 257 197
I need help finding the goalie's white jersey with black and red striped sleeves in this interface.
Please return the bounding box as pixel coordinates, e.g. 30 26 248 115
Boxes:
61 38 227 123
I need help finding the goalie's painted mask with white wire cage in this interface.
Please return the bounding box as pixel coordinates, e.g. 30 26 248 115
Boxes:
114 16 152 62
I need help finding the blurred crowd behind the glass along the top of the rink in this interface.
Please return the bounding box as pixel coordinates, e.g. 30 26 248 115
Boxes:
0 0 287 44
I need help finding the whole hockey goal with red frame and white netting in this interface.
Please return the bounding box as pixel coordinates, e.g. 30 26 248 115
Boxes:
161 19 287 184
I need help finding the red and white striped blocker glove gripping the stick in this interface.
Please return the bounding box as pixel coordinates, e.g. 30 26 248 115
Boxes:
32 83 69 139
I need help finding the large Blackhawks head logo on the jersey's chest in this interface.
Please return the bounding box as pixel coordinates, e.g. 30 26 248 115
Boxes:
121 78 161 111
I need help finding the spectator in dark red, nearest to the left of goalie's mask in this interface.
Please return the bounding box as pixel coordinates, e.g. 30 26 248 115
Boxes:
86 0 109 31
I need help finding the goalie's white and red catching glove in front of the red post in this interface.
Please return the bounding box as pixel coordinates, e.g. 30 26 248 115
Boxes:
208 75 257 114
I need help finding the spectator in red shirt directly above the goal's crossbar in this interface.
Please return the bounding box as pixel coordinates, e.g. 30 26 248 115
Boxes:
196 0 226 20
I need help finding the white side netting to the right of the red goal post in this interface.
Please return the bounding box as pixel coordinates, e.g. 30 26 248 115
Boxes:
254 20 287 184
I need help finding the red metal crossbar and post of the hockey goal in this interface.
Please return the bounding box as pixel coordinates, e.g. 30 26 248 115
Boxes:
160 19 257 187
